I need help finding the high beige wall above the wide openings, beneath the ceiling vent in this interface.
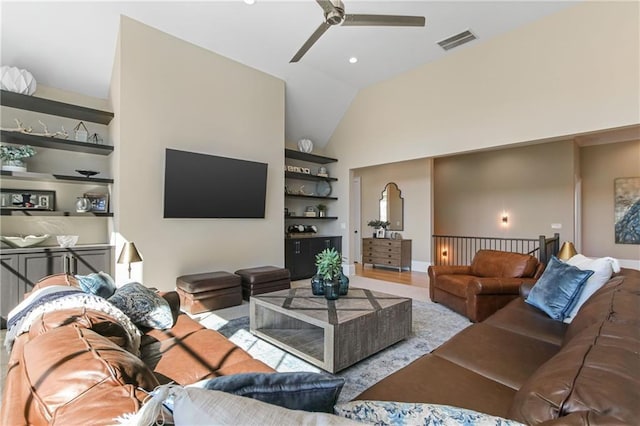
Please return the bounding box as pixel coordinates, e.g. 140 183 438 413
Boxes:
326 2 640 264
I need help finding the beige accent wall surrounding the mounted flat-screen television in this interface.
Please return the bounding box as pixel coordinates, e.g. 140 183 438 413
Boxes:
112 17 284 290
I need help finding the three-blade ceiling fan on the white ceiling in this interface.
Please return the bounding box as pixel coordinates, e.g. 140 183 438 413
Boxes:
289 0 425 63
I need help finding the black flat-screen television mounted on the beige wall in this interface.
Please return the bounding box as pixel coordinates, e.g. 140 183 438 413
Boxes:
164 149 267 218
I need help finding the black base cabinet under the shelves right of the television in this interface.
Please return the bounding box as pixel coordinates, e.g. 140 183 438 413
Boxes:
284 236 342 280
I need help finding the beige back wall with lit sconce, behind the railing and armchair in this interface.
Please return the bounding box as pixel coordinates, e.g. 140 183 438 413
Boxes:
433 141 575 241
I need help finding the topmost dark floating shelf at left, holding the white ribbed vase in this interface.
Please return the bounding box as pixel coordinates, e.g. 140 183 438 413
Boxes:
0 90 113 124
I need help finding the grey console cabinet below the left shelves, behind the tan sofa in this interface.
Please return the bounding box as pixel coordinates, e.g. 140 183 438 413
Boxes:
0 244 113 328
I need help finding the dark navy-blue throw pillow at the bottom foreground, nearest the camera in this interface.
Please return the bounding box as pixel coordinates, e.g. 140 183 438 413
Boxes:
188 372 344 413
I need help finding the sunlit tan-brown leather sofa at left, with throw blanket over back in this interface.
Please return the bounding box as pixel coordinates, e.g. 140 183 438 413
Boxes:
0 274 274 426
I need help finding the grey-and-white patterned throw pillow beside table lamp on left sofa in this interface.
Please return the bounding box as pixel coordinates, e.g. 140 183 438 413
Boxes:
107 282 173 330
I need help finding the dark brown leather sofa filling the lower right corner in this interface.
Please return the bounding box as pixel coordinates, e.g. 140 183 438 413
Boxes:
356 268 640 425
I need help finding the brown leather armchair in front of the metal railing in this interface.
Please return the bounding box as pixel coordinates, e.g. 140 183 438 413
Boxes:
428 250 544 322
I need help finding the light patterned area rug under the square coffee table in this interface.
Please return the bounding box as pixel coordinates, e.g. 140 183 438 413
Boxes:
212 300 471 402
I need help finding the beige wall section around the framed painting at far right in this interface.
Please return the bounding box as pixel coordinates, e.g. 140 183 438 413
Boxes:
580 141 640 262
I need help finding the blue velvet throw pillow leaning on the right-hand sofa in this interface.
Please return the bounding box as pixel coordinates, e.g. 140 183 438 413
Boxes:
525 256 593 321
